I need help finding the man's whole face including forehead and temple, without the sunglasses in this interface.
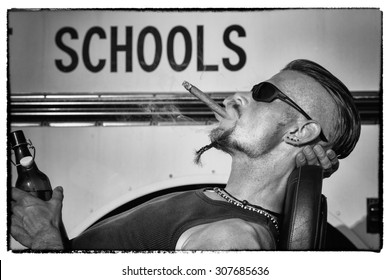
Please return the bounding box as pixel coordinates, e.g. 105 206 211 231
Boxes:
210 71 327 158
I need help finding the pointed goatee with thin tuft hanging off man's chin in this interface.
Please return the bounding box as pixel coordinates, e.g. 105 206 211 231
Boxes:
194 128 233 166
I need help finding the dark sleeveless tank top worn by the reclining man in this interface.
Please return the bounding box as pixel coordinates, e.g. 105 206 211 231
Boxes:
70 189 277 251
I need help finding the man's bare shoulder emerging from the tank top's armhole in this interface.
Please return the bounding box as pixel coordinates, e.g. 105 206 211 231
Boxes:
182 218 275 250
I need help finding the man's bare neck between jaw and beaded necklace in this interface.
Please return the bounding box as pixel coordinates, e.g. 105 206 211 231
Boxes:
226 150 295 213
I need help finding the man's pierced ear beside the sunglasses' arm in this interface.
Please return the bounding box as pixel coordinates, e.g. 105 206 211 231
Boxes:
283 120 321 146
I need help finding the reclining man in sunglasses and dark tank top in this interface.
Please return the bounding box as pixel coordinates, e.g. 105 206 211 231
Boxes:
11 60 360 250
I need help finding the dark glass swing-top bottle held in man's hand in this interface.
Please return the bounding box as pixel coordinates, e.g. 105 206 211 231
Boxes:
9 130 53 201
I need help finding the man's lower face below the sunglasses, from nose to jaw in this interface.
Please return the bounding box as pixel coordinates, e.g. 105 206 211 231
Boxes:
210 86 297 158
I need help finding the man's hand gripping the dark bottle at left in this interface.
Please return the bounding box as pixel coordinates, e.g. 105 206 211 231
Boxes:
11 187 64 250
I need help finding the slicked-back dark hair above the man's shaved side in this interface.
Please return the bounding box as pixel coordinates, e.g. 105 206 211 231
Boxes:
282 59 361 159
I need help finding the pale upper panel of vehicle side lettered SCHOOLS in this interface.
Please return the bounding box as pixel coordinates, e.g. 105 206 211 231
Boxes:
9 9 381 93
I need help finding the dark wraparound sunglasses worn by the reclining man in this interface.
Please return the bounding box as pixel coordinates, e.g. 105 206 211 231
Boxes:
252 82 328 142
